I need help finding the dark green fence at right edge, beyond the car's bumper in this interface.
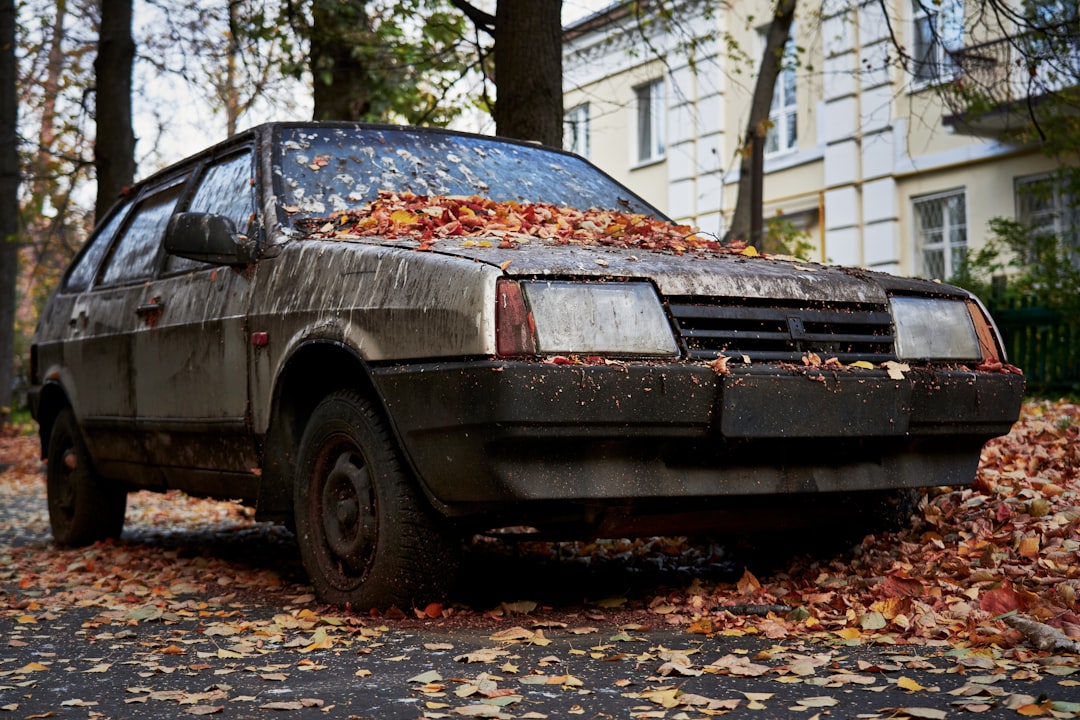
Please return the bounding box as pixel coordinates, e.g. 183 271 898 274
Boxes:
989 302 1080 393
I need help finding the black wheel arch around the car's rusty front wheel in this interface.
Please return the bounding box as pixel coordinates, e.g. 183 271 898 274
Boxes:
256 339 388 522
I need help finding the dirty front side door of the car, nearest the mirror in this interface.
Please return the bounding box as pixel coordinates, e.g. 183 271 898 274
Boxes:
134 148 257 498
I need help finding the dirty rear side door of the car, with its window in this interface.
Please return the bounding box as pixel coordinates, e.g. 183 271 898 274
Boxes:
64 175 186 485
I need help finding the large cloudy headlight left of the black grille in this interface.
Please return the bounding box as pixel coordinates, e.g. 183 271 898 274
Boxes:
499 281 678 356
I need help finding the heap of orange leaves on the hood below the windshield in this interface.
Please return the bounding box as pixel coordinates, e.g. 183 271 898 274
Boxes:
300 191 746 255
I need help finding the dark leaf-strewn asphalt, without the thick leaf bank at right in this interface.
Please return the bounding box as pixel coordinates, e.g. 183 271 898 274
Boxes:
0 427 1080 720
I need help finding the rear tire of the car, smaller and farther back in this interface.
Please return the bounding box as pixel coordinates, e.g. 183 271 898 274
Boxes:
45 407 127 546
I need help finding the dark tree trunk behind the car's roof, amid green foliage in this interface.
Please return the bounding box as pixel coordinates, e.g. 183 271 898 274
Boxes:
309 0 373 121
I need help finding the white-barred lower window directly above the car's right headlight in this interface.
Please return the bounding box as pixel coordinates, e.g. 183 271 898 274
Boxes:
915 190 968 280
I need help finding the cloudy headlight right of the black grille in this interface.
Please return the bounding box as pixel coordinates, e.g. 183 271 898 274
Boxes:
890 298 983 361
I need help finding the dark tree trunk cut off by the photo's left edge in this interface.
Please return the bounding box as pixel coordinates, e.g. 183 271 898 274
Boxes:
0 0 19 426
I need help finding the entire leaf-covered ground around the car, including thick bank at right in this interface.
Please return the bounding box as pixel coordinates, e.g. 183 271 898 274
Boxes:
0 403 1080 720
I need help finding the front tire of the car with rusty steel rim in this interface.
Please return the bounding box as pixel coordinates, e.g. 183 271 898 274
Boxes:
294 391 460 610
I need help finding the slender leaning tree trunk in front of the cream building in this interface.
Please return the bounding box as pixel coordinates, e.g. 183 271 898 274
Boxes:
724 0 796 247
